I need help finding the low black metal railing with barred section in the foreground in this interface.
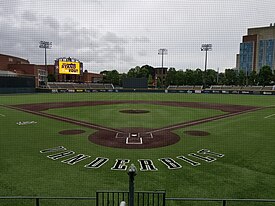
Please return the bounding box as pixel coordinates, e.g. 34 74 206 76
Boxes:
0 196 275 206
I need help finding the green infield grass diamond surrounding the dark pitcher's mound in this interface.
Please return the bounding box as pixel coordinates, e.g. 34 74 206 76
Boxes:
47 104 225 128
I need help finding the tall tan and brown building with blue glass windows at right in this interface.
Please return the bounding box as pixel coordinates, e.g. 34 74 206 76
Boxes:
236 23 275 74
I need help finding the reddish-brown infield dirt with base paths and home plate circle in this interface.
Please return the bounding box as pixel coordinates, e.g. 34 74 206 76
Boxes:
7 100 261 149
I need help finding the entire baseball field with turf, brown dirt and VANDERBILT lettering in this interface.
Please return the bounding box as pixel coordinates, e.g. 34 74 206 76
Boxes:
0 93 275 206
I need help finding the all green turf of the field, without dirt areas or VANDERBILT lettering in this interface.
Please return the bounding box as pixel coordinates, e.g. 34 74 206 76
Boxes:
0 93 275 206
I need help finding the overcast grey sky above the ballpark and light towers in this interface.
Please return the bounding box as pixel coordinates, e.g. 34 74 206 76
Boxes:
0 0 275 72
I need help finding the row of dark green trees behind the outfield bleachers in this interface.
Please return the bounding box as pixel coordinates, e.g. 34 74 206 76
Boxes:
100 65 275 87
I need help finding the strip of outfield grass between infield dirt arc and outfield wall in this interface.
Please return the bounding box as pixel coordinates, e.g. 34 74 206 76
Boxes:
0 93 275 106
